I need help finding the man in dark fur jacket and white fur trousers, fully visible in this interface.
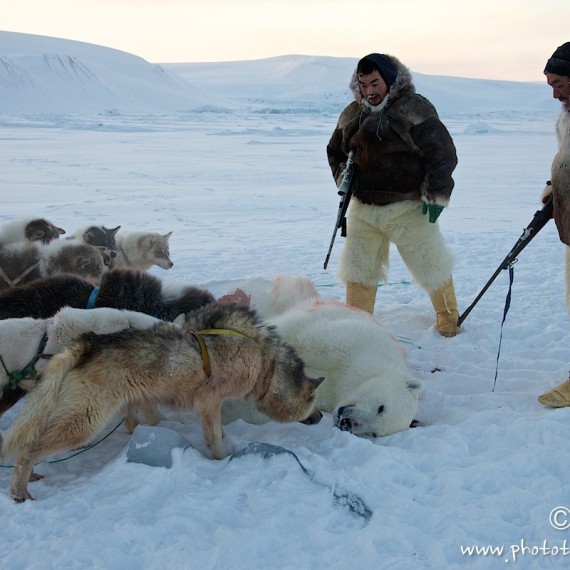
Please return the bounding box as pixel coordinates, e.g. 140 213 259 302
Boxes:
327 53 460 337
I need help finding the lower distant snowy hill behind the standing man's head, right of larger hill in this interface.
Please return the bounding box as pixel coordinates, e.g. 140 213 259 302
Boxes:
164 55 552 116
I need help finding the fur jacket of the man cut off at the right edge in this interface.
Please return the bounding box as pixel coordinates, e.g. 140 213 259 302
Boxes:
551 109 570 245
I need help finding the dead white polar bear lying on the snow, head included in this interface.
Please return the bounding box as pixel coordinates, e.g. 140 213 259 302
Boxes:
223 276 421 436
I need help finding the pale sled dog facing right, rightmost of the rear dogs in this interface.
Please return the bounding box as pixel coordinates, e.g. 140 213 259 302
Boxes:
111 232 174 271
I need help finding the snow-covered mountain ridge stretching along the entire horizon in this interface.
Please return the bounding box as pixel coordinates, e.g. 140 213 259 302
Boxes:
0 31 555 116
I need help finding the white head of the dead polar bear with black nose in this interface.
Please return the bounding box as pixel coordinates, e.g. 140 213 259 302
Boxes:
333 375 421 437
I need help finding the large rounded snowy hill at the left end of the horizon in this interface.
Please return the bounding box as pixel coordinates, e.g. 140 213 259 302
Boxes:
0 32 211 113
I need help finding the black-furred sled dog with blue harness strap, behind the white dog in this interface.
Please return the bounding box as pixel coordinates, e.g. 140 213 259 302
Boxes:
0 269 214 321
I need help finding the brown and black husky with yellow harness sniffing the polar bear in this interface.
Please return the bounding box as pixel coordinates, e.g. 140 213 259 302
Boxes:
2 302 323 502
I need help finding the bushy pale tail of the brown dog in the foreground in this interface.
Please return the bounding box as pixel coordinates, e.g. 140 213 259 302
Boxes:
1 347 80 457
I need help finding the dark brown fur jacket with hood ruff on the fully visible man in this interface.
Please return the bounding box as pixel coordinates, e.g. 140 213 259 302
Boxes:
327 56 457 206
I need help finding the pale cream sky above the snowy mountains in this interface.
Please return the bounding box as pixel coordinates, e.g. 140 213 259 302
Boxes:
4 0 570 81
